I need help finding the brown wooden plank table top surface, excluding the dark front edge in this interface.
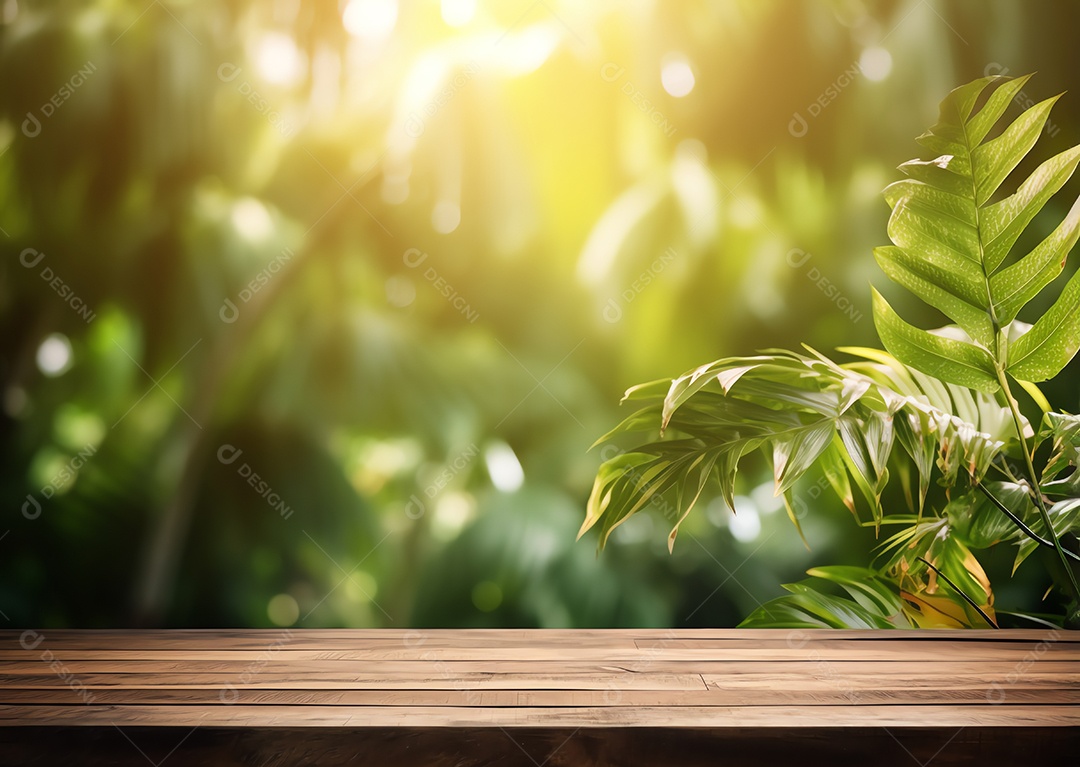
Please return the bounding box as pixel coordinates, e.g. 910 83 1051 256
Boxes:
0 629 1080 728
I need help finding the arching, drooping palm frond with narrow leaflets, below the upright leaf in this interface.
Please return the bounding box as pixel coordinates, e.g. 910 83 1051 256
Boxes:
581 341 1011 566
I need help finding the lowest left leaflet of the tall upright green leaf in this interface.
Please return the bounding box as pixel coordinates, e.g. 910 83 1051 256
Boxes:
874 290 999 392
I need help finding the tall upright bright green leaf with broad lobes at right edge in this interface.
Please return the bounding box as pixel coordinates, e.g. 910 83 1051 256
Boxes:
874 76 1080 392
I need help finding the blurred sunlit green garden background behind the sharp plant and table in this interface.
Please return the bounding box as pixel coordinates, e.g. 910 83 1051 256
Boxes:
0 0 1080 628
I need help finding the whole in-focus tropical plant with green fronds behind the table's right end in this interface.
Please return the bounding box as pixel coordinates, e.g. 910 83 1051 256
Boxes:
579 76 1080 628
